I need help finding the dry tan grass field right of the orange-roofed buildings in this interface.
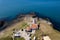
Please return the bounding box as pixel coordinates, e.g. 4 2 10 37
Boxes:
34 22 60 40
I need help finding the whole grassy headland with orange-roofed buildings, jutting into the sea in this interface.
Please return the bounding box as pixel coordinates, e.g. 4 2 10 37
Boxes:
0 12 60 40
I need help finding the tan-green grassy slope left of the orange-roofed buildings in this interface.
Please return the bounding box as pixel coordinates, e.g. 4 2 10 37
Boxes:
0 21 28 38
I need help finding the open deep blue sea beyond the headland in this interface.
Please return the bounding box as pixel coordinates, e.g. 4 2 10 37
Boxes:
0 0 60 30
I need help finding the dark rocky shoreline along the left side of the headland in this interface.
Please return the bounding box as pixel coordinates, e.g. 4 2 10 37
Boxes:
0 12 35 31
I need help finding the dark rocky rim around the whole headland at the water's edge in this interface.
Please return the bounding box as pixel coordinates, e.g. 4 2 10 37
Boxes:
0 12 59 31
